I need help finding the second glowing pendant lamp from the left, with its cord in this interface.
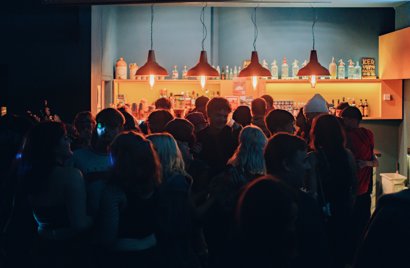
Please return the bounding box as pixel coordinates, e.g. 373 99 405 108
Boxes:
187 5 219 89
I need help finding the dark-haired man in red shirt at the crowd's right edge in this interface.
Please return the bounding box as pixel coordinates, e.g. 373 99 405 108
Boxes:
340 106 379 258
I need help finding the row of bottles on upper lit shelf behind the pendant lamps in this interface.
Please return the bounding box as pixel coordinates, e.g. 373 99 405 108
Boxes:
115 57 362 80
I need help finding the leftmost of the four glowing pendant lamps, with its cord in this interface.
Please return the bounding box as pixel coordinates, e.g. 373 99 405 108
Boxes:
136 5 168 88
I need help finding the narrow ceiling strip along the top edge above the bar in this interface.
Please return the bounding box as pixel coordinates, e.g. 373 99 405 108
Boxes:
42 0 409 8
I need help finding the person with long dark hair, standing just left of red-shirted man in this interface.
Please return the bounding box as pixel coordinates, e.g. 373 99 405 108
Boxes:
310 115 357 267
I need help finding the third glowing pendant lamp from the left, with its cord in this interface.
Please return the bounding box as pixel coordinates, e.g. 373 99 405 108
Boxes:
238 7 271 90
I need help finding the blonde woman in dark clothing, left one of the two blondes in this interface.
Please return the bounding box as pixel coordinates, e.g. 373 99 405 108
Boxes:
147 133 199 268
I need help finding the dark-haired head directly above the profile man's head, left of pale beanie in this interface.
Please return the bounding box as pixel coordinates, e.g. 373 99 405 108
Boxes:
265 109 296 136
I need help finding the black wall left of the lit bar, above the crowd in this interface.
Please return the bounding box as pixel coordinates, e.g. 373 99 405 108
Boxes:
0 0 91 121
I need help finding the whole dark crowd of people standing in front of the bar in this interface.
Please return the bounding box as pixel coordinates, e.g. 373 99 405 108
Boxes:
0 94 410 268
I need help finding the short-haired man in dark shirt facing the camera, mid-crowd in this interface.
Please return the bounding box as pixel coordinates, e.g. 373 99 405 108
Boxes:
197 97 241 175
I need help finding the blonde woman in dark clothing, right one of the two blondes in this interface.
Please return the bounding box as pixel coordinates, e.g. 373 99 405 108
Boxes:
203 126 267 266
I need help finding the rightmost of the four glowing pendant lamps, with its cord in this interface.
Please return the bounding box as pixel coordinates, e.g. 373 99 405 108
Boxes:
297 8 330 88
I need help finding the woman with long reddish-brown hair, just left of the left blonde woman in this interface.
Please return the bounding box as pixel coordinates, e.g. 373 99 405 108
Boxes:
96 132 161 267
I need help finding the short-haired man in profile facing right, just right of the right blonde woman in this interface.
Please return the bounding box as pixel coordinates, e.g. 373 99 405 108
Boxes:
265 133 330 267
